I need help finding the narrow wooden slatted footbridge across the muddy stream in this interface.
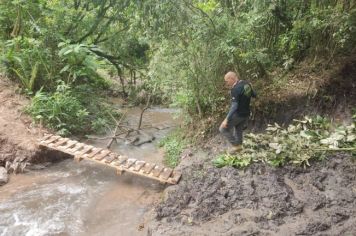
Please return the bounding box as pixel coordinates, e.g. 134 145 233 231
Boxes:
40 135 181 184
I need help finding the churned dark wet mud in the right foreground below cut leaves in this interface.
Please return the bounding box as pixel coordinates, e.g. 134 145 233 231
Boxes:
150 155 356 235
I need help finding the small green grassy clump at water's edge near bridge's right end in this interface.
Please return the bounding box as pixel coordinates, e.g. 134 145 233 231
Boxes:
159 130 187 168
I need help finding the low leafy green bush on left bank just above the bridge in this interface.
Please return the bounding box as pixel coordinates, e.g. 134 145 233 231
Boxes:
27 83 118 136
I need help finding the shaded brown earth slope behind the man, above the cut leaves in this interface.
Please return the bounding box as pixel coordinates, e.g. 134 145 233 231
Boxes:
249 55 356 130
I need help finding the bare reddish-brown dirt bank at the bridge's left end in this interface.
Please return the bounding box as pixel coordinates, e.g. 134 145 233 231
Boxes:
0 75 44 166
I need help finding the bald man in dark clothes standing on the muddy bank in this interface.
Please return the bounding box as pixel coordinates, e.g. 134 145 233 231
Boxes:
219 71 256 154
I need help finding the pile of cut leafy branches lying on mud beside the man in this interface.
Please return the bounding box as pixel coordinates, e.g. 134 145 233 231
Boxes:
213 116 356 168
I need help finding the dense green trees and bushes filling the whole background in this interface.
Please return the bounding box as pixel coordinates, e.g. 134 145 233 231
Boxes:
0 0 356 136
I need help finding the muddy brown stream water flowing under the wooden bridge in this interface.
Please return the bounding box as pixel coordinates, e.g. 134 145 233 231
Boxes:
0 108 176 236
